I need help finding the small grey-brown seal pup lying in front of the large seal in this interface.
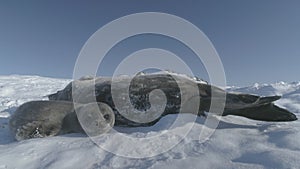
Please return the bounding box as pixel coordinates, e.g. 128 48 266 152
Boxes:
9 101 115 141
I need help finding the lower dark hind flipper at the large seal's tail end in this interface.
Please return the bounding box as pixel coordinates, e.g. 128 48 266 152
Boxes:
223 103 297 121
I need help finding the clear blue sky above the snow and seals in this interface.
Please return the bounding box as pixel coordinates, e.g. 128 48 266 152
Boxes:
0 0 300 86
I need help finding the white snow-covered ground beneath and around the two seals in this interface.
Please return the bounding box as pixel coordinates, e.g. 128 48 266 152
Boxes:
0 75 300 169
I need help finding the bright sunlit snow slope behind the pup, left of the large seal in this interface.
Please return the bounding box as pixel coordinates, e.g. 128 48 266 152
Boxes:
0 75 71 112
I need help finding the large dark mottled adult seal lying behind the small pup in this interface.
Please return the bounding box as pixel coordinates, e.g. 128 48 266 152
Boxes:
48 72 297 127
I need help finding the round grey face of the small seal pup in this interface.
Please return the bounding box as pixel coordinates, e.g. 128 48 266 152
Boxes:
75 103 115 137
